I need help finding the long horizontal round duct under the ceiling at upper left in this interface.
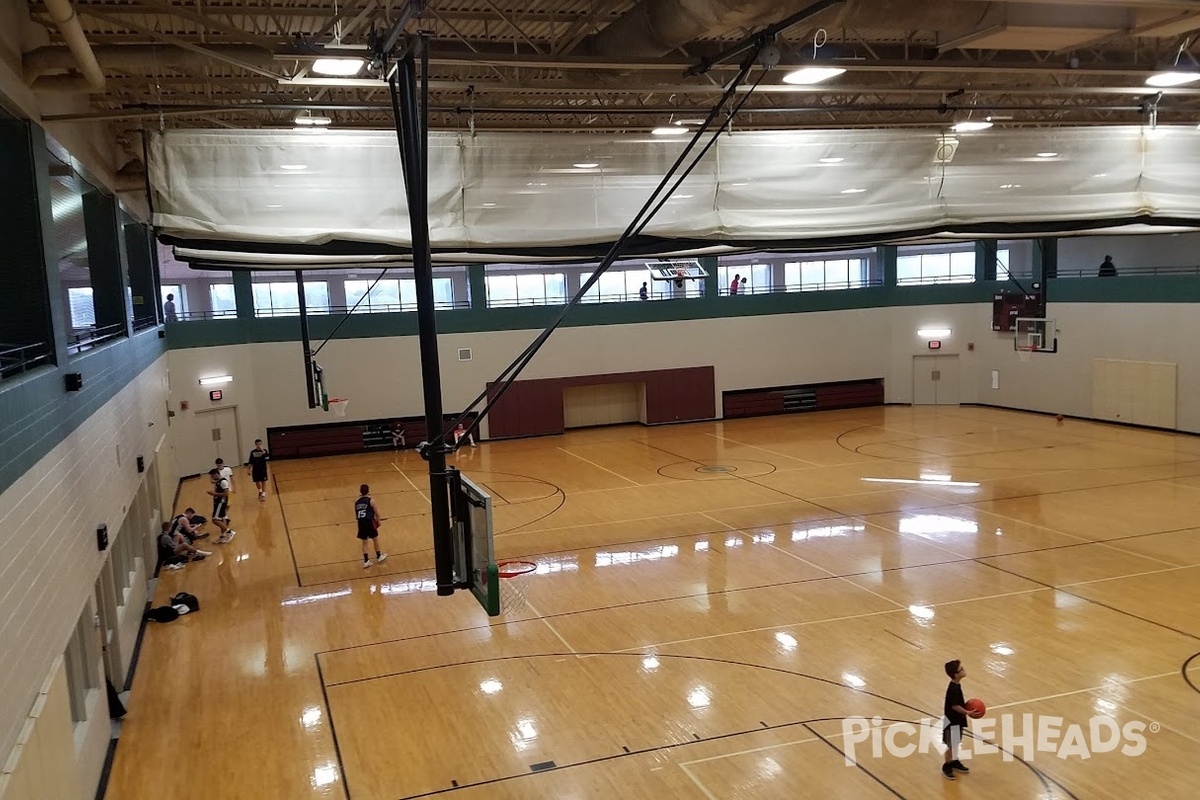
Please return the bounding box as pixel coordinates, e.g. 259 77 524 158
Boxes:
22 44 275 90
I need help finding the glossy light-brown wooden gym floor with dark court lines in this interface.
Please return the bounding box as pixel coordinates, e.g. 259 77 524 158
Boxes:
107 408 1200 800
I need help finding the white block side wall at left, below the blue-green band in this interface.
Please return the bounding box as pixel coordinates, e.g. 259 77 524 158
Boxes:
0 356 175 798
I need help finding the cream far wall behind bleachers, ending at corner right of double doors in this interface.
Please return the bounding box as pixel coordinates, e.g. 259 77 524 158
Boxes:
168 305 991 453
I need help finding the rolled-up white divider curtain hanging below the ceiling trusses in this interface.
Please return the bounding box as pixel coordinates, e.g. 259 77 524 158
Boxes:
149 127 1200 260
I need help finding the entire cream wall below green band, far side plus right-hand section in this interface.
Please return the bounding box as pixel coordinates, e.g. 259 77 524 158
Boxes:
168 303 1200 448
